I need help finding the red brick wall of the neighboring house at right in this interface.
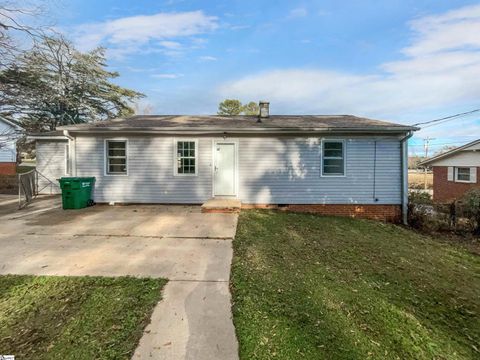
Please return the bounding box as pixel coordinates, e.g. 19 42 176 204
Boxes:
433 166 480 203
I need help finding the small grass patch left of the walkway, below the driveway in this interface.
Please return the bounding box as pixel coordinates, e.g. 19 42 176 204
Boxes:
0 275 166 360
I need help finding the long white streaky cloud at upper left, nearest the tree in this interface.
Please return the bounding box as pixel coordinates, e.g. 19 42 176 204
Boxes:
73 11 218 56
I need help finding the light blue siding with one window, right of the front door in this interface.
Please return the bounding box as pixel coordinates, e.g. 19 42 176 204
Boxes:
239 138 401 204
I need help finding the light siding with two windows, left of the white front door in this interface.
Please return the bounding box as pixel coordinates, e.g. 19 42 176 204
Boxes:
76 136 212 204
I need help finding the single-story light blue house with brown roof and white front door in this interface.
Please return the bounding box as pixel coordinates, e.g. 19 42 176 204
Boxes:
32 103 416 221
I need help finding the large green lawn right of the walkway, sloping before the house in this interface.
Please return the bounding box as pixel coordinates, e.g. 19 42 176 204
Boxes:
231 210 480 359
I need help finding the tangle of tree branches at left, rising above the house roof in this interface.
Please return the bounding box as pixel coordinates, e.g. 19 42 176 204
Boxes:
0 0 142 131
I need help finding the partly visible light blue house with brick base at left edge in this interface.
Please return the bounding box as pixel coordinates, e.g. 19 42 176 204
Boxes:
0 117 22 175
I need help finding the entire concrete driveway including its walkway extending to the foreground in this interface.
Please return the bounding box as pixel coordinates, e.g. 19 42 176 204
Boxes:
0 197 238 359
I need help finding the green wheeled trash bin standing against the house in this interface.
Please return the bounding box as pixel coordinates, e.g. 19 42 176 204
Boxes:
58 177 95 209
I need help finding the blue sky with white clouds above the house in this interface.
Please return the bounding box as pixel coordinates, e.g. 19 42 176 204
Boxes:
46 0 480 154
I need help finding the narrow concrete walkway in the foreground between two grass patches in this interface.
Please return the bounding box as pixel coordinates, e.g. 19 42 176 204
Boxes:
133 281 238 360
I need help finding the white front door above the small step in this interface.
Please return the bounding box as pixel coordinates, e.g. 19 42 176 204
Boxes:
213 142 236 196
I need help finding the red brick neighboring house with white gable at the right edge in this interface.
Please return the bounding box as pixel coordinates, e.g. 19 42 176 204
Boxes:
419 139 480 203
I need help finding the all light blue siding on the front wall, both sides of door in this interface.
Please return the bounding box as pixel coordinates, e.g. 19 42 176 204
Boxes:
39 136 401 204
